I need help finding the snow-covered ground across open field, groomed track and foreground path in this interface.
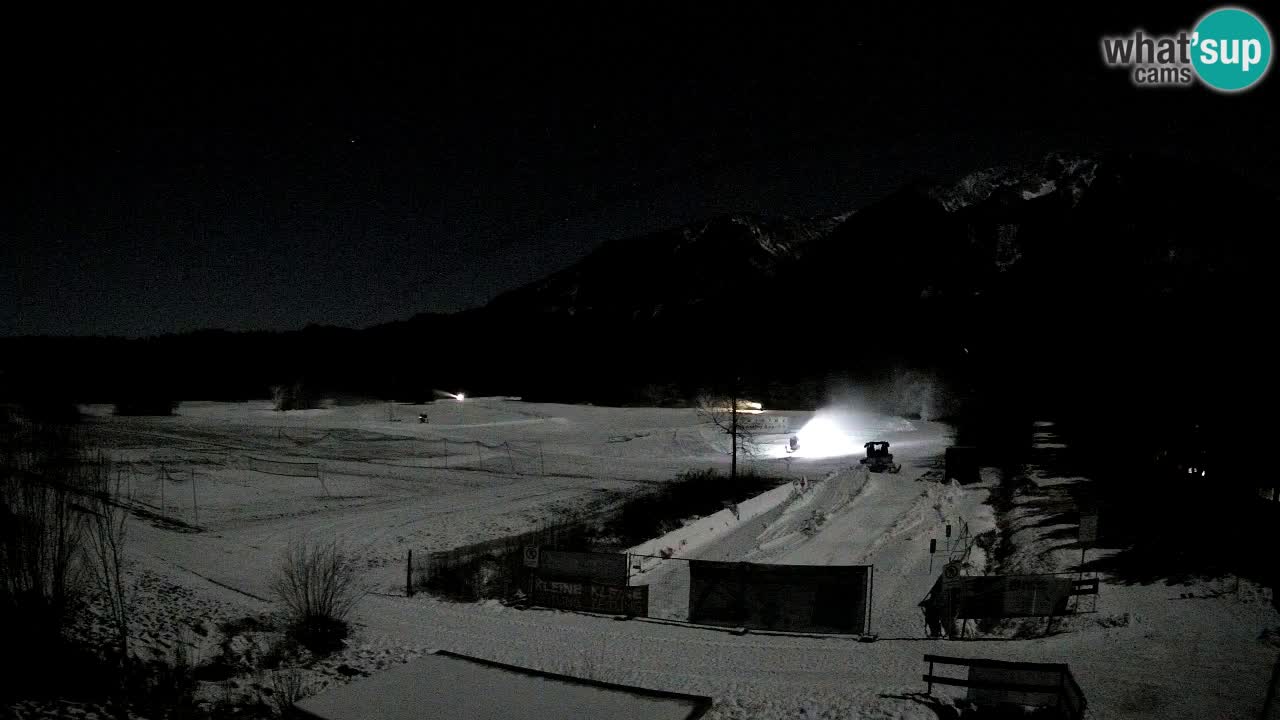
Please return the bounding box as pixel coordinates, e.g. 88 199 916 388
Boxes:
42 398 1280 717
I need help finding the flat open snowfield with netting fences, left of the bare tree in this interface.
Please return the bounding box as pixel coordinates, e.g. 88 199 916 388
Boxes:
77 398 877 597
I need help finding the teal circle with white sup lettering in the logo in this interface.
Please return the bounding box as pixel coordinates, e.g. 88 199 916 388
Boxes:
1192 8 1271 92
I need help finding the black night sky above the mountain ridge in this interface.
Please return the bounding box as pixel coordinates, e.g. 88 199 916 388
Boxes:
0 4 1280 336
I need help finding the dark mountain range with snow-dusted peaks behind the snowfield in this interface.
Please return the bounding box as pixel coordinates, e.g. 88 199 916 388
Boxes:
0 154 1276 420
